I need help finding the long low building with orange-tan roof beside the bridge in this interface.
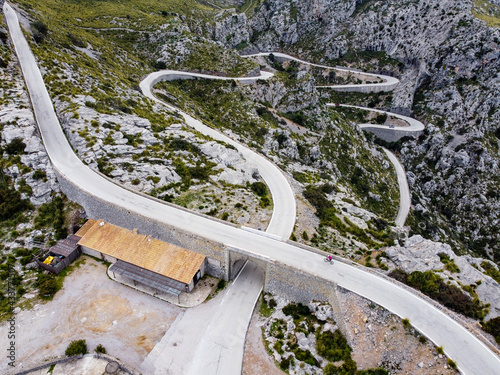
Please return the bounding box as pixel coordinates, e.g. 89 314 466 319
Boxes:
76 220 206 295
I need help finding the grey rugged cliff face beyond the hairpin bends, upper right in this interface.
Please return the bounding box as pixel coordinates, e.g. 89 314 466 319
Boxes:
215 0 500 262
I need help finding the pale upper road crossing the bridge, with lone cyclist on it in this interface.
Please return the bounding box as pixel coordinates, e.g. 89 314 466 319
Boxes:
4 3 500 375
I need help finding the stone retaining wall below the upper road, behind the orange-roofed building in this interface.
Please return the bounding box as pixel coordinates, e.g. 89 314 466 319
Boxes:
57 174 229 280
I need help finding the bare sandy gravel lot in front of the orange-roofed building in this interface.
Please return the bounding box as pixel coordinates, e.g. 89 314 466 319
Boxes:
0 257 181 374
